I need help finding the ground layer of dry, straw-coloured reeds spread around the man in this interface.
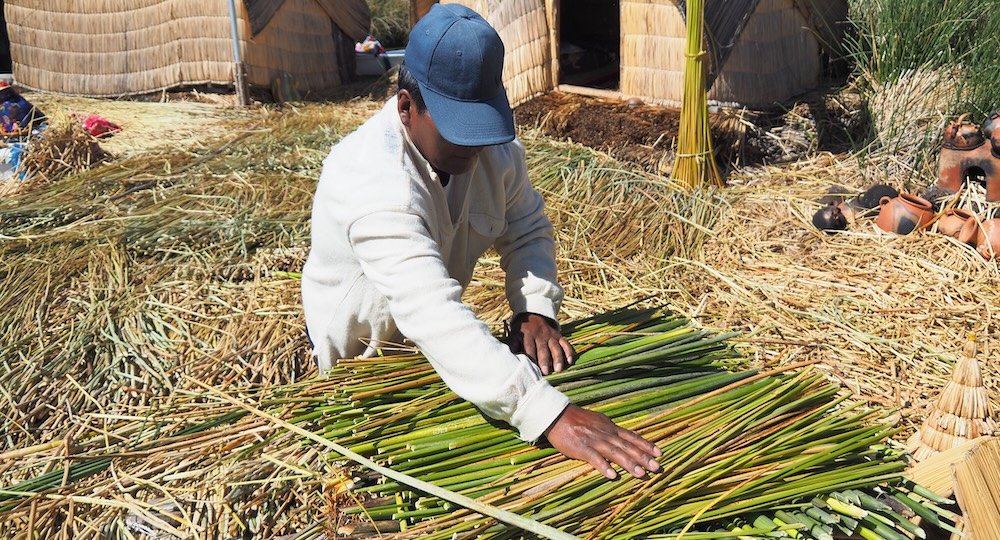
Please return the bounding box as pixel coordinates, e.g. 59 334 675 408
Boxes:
0 90 1000 538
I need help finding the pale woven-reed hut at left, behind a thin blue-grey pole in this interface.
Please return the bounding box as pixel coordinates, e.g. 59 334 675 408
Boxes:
4 0 371 96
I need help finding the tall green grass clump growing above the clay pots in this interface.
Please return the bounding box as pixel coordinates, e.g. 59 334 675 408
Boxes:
845 0 1000 180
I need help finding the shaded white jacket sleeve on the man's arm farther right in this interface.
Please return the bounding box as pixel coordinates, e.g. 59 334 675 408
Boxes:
494 142 563 321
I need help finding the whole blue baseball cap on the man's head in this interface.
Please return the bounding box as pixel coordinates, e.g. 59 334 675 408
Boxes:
405 4 514 146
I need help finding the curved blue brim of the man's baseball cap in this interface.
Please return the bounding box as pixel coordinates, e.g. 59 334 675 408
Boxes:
418 83 514 146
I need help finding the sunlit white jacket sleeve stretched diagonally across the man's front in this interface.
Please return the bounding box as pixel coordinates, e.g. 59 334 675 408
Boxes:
349 211 569 441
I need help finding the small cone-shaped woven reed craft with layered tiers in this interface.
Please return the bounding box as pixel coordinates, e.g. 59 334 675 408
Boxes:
908 334 996 461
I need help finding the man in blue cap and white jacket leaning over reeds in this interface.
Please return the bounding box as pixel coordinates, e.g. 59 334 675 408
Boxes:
302 4 660 478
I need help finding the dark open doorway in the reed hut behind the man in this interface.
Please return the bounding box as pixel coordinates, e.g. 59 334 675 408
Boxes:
557 0 621 90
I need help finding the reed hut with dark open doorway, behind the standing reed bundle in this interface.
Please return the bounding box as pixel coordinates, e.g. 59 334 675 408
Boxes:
422 0 847 107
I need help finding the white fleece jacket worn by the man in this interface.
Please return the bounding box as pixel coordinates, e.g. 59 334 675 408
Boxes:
302 98 569 441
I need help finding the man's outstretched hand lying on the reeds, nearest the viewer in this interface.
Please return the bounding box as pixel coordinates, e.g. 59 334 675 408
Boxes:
545 405 662 479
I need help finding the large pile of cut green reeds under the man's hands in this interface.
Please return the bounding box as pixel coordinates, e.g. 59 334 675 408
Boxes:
300 311 953 539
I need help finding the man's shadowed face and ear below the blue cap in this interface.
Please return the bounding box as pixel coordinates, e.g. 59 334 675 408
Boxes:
396 90 483 174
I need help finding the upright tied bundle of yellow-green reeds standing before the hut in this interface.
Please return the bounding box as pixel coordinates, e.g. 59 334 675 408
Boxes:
670 0 722 189
